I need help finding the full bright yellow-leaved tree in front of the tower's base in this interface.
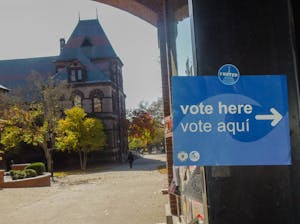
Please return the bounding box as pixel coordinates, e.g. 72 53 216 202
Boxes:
56 107 106 170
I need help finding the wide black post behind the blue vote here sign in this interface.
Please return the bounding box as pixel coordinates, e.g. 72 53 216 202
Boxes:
192 0 300 224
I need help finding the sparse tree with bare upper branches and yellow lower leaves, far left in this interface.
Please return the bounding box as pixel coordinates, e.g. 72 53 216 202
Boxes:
1 73 69 171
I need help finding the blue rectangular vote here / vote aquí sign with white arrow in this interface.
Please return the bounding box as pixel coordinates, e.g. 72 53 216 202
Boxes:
172 74 291 166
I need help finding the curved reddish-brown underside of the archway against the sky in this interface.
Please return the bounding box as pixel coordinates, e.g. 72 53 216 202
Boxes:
94 0 163 26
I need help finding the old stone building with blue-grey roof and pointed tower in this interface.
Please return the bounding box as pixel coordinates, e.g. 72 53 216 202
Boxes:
0 19 127 161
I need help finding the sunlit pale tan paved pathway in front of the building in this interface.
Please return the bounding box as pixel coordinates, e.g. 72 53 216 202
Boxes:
0 155 167 224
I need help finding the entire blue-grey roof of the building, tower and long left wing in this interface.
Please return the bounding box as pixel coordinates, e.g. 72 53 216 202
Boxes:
0 19 122 88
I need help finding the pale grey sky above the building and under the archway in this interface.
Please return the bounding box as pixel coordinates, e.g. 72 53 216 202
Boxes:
0 0 162 108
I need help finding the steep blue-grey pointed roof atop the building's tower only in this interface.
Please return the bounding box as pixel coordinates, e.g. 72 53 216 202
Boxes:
57 19 120 61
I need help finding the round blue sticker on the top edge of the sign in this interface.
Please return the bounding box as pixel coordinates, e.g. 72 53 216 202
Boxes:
218 64 240 85
